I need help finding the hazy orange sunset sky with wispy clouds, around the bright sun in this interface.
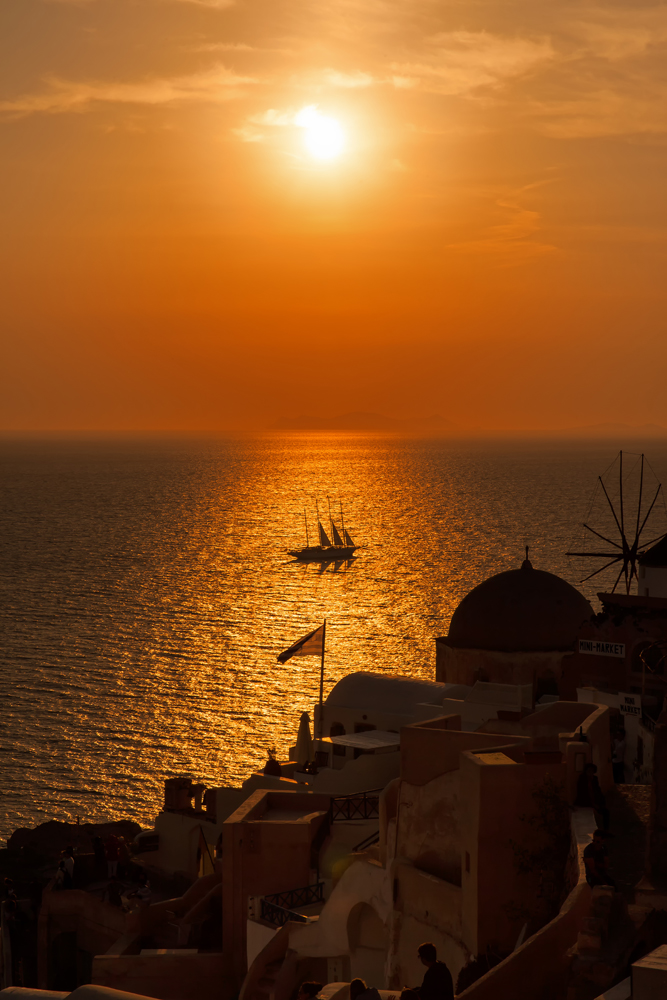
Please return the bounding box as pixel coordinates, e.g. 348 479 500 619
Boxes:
0 0 667 430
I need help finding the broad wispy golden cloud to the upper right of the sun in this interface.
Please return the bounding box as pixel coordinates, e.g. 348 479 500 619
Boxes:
391 31 554 95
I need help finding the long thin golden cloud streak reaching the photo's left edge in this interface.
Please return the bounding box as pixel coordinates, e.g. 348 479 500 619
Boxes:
0 65 256 116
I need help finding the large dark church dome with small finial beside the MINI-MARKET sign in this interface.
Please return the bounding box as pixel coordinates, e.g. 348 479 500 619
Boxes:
446 559 593 652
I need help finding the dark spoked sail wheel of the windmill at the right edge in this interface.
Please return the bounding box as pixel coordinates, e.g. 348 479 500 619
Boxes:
566 451 667 594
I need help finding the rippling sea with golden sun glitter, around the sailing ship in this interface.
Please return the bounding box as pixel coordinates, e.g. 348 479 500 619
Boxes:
0 433 667 842
